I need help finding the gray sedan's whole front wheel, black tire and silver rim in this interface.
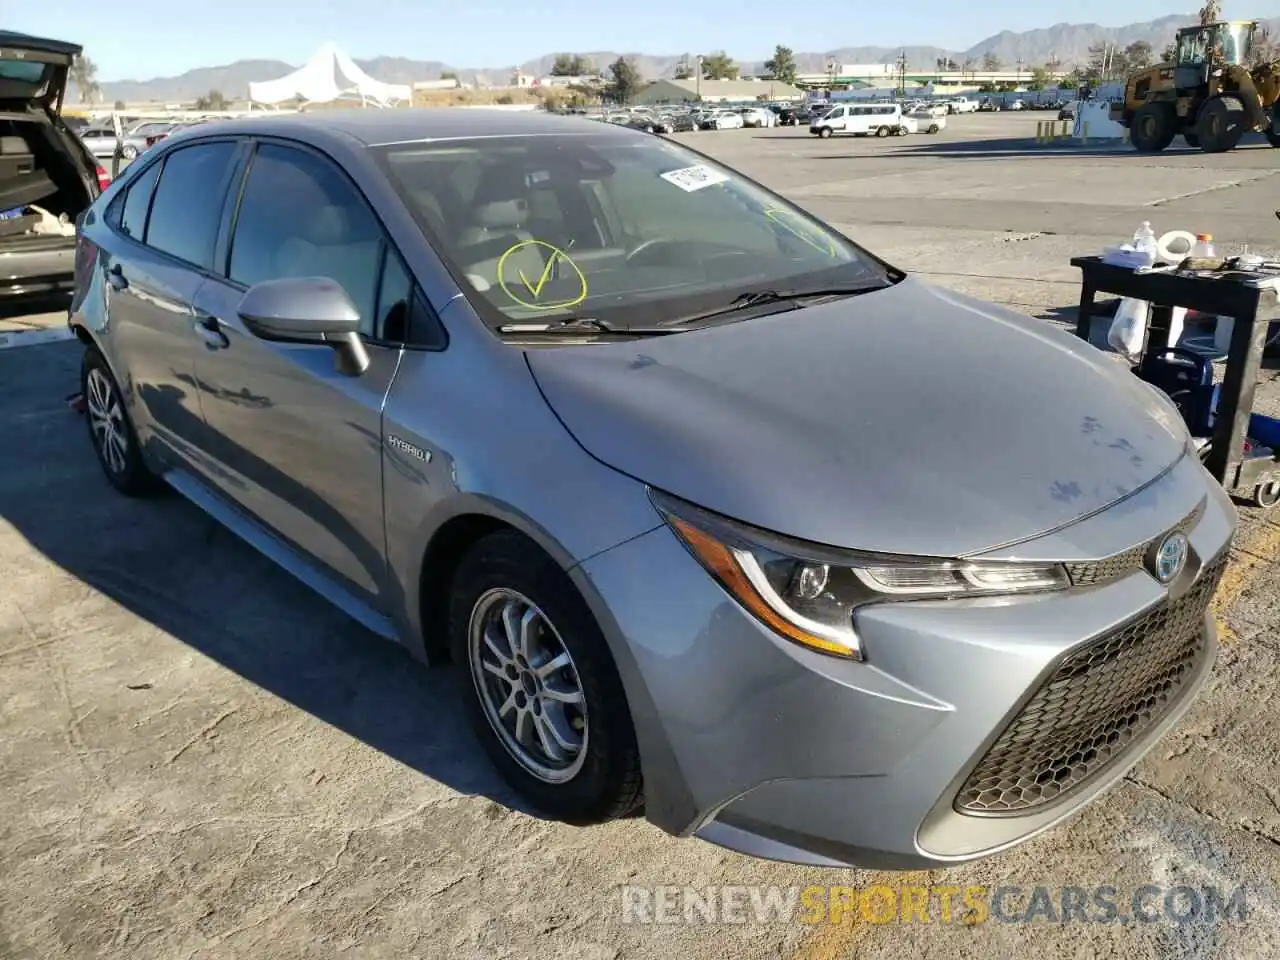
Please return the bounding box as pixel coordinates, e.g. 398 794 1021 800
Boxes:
449 531 643 823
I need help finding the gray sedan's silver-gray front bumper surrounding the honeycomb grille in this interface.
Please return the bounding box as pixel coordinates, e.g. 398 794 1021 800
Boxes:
582 458 1235 869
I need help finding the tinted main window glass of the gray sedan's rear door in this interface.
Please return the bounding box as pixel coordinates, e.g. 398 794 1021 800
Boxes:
146 140 239 270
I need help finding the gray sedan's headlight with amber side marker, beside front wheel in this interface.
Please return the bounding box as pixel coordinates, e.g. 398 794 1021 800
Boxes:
650 490 1070 660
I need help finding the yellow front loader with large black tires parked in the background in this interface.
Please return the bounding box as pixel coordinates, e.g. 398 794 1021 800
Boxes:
1111 20 1280 154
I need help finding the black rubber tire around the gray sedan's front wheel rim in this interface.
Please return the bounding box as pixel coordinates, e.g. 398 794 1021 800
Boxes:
449 530 643 823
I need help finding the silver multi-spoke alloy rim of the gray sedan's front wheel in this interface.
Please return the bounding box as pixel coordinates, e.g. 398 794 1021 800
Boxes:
467 588 589 783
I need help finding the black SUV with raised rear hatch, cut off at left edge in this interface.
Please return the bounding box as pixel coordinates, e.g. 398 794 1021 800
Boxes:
0 31 108 297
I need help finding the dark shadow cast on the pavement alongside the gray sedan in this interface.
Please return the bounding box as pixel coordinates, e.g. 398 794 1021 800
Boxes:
0 343 550 829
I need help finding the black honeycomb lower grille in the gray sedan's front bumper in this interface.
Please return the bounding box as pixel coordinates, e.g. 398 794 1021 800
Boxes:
955 557 1226 814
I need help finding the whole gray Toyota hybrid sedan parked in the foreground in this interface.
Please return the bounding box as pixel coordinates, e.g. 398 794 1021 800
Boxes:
70 110 1236 868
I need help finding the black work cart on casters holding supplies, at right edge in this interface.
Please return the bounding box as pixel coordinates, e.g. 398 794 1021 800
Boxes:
1071 256 1280 507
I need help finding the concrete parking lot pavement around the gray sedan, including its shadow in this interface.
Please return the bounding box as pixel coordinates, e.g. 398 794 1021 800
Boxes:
0 113 1280 960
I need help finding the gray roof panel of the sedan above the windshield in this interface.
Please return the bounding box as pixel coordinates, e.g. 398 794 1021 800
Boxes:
180 108 640 146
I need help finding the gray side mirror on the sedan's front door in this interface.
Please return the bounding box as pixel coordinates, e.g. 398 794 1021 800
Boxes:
236 276 369 376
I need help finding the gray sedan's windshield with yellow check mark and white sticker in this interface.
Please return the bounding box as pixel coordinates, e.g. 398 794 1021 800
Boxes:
375 132 897 329
